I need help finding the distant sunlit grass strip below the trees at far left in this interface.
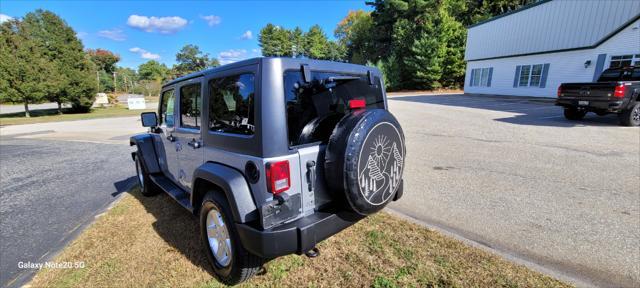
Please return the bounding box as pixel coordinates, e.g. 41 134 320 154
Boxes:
0 105 155 126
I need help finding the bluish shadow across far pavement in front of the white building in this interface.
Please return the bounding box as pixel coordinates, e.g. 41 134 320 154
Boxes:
389 94 618 127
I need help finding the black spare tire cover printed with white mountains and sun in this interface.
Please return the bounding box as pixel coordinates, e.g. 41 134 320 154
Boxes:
324 109 405 215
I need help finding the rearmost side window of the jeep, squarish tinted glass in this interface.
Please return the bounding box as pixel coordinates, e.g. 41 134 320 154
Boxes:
209 73 255 135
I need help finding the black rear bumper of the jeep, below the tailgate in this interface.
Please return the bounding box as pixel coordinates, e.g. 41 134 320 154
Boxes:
236 211 364 259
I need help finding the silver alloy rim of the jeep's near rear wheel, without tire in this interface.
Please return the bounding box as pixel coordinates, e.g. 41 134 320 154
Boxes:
207 208 232 267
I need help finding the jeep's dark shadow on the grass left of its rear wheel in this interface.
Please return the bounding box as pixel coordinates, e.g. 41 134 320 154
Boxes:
128 188 214 276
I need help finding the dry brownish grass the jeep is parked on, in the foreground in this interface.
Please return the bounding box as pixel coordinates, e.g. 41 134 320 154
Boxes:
29 189 569 287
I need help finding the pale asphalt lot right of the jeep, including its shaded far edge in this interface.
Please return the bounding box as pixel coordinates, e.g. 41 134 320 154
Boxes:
388 95 640 287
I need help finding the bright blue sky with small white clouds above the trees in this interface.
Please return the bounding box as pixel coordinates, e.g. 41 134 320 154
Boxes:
0 0 371 68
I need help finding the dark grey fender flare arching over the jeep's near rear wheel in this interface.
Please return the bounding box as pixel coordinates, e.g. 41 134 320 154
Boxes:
191 163 258 223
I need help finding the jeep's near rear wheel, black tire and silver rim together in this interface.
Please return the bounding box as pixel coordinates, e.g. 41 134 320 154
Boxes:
200 191 263 285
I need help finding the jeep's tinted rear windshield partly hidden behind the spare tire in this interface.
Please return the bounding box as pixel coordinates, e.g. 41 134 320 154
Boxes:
284 71 384 146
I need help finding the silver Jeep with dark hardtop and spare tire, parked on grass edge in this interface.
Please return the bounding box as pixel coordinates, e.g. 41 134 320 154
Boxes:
130 58 405 284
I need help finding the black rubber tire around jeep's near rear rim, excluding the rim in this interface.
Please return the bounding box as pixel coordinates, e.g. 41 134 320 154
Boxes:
200 191 264 285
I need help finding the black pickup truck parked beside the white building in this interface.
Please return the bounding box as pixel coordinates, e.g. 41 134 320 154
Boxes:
556 66 640 126
